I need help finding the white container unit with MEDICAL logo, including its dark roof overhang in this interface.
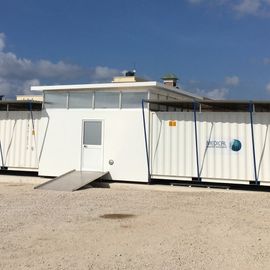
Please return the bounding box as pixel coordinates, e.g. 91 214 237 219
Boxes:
148 101 270 185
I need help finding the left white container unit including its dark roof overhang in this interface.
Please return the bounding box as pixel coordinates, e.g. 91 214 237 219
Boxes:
0 101 42 171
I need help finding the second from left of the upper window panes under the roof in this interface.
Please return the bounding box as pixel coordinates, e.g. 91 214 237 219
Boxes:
68 92 93 109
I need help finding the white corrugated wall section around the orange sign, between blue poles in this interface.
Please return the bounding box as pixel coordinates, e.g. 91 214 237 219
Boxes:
151 112 195 177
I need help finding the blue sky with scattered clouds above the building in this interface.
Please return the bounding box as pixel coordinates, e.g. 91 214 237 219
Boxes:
0 0 270 99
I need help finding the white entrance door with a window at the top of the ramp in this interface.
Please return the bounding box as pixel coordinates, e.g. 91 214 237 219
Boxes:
81 120 103 171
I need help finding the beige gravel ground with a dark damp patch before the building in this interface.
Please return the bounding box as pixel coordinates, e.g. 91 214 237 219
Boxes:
0 183 270 269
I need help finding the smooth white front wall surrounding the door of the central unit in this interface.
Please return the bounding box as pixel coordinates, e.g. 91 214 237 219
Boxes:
39 109 148 182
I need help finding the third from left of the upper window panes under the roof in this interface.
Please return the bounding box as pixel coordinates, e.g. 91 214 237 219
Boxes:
95 92 120 108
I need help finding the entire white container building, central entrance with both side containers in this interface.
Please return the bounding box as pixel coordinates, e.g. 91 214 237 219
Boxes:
0 76 270 188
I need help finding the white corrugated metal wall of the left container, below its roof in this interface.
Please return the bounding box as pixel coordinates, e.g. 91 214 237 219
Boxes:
0 111 41 169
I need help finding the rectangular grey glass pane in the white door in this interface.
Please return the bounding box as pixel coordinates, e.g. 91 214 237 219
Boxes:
83 121 102 145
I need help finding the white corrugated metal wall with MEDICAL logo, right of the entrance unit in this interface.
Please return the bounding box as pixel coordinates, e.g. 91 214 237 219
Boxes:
150 112 270 183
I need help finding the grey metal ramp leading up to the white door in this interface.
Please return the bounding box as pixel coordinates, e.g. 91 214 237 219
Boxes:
35 170 108 191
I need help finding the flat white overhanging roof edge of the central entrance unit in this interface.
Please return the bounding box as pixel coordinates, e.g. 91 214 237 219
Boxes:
31 81 203 99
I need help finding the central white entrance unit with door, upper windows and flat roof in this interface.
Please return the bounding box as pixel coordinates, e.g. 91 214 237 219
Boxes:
32 82 200 182
